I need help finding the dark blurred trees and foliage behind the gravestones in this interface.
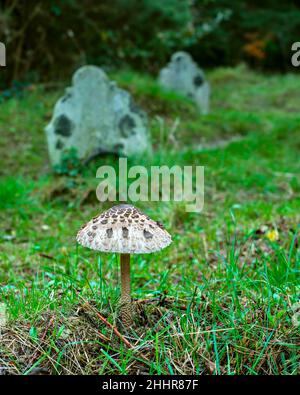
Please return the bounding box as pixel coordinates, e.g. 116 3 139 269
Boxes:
0 0 300 88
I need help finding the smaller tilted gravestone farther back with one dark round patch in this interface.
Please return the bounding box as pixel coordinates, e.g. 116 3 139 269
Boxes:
159 52 210 114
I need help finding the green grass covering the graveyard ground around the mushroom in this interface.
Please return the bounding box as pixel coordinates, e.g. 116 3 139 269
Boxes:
0 66 300 374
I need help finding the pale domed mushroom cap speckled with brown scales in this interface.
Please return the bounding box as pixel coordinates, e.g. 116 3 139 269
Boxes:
76 204 172 254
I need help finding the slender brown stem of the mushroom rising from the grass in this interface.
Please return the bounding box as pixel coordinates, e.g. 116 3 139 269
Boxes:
120 254 133 328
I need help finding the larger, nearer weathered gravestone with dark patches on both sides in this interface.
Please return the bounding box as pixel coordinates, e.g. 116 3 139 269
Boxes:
45 66 150 165
